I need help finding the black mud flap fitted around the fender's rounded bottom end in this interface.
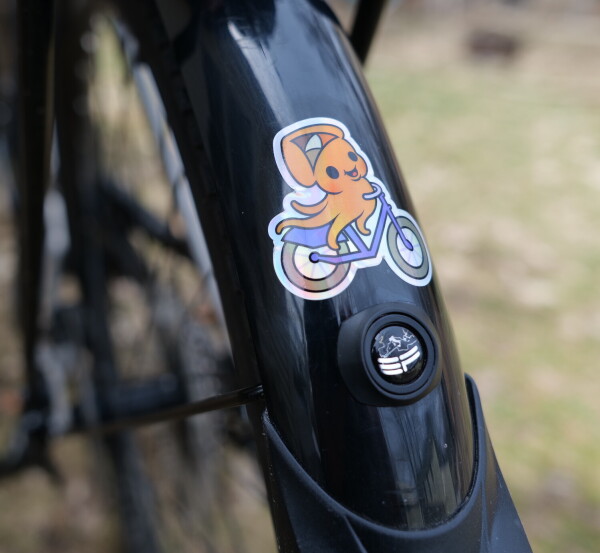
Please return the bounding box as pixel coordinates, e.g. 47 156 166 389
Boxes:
263 379 531 553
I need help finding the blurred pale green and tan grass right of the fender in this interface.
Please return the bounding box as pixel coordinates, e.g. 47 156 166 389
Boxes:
367 6 600 553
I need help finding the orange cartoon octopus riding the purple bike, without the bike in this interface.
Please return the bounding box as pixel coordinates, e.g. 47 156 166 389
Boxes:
275 125 376 250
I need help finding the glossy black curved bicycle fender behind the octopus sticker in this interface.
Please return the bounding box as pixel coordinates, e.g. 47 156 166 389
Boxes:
154 0 474 529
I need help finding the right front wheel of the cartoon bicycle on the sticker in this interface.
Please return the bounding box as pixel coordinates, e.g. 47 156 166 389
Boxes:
387 215 431 281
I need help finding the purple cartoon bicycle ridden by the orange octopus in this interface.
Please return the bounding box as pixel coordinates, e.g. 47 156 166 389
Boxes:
274 182 432 299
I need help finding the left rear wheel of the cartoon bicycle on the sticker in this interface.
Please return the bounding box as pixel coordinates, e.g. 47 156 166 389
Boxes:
281 242 350 293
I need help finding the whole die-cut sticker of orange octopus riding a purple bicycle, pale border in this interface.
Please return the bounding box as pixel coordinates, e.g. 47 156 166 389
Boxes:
269 117 432 300
